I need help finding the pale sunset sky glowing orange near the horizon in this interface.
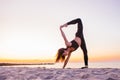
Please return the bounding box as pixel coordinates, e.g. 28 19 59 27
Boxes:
0 0 120 61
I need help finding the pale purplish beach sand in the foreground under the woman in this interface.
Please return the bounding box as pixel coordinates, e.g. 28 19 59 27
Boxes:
0 67 120 80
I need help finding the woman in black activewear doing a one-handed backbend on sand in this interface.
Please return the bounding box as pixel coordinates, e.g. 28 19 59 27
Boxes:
56 18 88 68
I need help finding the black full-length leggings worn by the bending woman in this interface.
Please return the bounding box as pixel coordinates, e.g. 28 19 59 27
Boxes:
67 18 88 66
